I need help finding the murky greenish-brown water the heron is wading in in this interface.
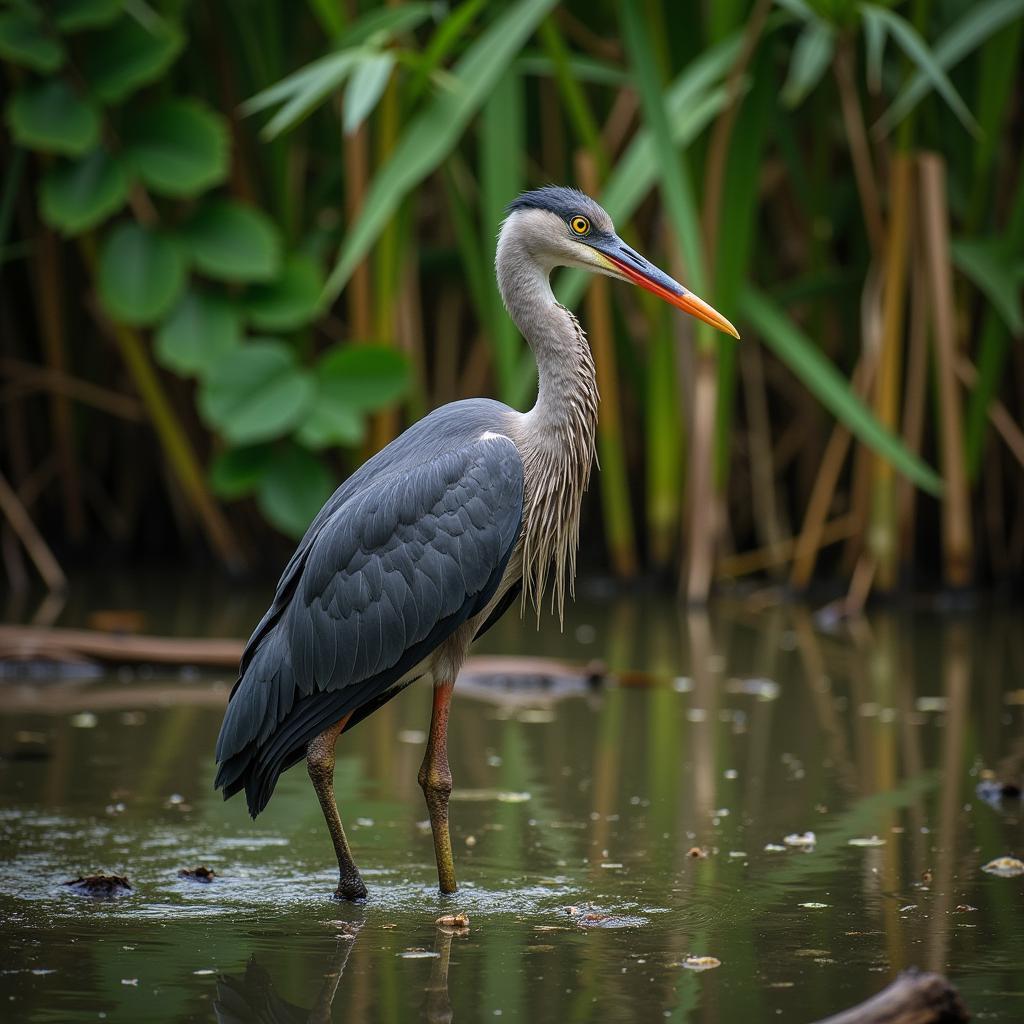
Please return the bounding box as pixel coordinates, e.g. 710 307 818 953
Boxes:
0 584 1024 1022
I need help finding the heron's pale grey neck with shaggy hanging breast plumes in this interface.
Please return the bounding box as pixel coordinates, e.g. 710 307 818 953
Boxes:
497 232 598 622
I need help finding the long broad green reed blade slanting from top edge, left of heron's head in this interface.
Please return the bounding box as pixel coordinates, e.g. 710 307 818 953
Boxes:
323 0 555 301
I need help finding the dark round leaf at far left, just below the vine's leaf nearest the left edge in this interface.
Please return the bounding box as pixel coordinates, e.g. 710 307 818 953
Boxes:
39 148 128 234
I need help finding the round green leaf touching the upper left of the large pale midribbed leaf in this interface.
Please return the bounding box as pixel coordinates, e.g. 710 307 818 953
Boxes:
154 288 242 377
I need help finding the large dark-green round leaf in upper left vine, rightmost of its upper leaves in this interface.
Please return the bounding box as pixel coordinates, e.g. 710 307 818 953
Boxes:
122 98 228 197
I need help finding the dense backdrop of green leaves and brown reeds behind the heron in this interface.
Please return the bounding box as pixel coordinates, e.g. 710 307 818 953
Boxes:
0 0 1024 606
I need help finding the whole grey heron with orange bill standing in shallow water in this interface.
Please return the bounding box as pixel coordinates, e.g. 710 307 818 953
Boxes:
215 185 739 901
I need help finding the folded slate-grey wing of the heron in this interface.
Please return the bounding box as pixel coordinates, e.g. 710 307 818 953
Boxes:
217 435 523 815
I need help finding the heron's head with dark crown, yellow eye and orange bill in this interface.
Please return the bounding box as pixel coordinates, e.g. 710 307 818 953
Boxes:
500 185 739 338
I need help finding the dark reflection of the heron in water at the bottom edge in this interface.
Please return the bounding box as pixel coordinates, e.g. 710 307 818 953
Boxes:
213 922 457 1024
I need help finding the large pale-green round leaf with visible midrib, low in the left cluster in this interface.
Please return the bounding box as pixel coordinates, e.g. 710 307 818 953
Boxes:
199 341 315 444
